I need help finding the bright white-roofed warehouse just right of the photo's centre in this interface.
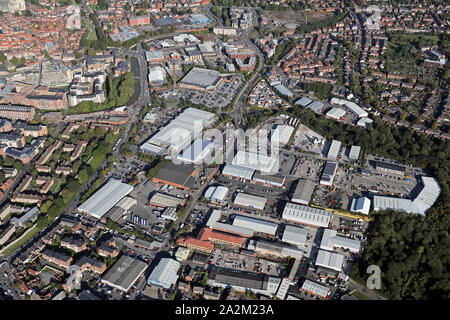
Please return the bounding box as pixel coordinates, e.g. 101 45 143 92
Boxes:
231 150 278 174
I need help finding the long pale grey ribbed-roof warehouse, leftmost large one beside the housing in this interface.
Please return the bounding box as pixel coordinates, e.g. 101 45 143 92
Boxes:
77 179 133 219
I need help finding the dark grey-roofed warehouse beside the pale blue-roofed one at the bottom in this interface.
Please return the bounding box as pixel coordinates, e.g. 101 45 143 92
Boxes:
101 255 147 292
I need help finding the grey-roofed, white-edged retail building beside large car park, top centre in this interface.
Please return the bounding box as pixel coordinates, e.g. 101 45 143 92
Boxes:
179 67 222 91
